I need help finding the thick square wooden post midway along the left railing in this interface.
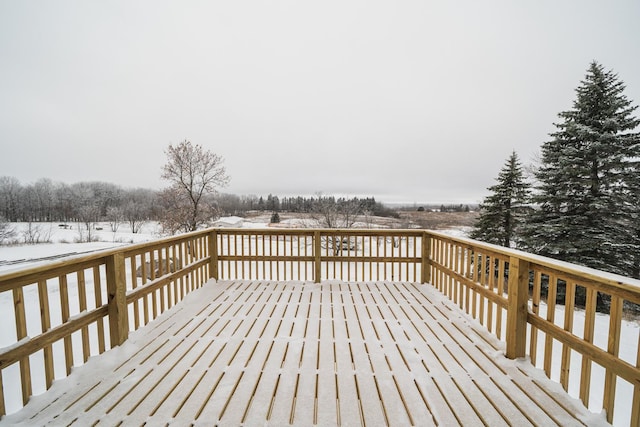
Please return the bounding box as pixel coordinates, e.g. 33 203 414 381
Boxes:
106 253 129 347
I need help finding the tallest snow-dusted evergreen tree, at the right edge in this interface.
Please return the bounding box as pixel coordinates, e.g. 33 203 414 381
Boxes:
526 62 640 274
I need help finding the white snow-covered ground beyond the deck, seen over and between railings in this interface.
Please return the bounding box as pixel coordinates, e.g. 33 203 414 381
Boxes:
0 221 640 425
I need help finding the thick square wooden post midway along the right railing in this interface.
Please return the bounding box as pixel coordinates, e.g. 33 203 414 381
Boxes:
508 256 529 359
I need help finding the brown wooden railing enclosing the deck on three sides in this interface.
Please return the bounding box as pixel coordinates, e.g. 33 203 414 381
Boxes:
0 228 640 426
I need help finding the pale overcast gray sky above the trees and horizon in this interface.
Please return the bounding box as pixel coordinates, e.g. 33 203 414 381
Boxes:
0 0 640 203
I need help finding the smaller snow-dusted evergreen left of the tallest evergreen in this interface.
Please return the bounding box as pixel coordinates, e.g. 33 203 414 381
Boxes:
470 151 530 247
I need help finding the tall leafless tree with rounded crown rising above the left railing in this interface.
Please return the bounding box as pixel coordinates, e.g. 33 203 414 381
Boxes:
162 140 229 231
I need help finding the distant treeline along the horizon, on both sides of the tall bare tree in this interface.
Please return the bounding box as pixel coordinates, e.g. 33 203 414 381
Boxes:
0 176 398 228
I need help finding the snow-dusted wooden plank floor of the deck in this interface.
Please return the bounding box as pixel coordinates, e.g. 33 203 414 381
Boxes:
0 281 606 426
